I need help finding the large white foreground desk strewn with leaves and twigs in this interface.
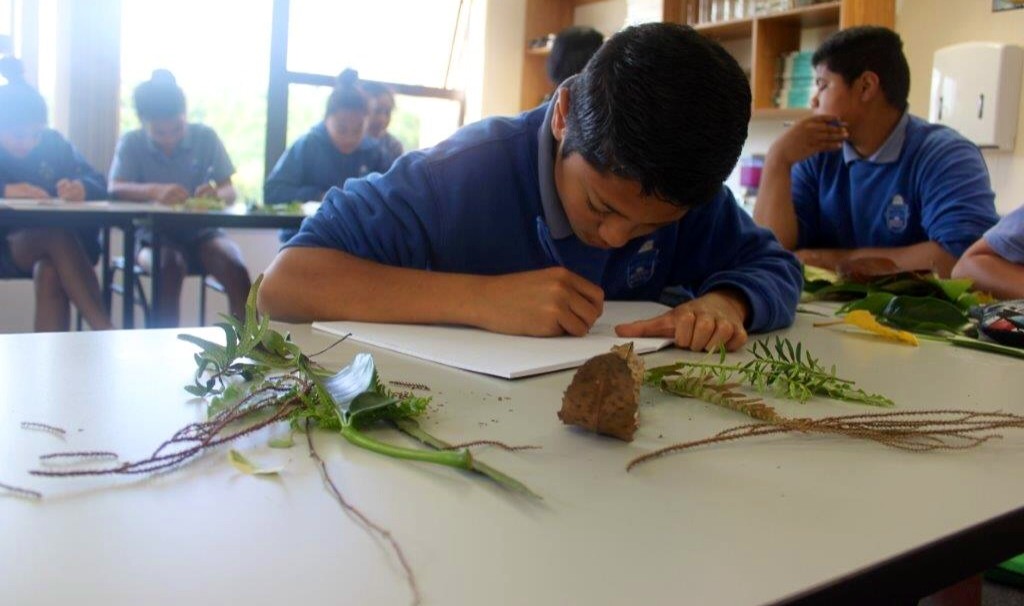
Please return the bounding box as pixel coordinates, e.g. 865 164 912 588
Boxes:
0 315 1024 606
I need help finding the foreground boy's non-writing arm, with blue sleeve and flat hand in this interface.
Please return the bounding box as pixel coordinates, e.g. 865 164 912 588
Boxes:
616 188 803 350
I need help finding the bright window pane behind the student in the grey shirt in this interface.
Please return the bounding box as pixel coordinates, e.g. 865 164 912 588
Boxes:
120 0 272 200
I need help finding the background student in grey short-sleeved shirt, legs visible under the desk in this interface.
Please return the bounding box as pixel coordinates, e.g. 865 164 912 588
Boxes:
111 70 251 327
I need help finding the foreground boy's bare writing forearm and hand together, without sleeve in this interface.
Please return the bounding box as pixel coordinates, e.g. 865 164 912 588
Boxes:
259 247 603 337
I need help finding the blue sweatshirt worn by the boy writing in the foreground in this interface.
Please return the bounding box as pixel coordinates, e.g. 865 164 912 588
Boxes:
287 101 802 332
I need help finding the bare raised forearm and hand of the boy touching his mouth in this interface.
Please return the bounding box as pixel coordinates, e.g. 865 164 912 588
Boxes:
754 116 849 251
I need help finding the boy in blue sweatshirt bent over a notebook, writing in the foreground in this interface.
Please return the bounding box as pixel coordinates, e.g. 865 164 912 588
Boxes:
259 24 802 350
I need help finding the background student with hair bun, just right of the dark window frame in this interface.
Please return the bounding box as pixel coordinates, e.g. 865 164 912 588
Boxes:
263 70 390 225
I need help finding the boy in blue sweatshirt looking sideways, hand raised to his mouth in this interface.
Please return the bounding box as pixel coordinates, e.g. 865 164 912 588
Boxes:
754 27 997 277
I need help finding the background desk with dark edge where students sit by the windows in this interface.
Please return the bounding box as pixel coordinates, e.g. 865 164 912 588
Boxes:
0 199 313 329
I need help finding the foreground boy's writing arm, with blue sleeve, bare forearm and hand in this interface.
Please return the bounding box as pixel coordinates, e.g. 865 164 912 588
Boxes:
259 155 604 336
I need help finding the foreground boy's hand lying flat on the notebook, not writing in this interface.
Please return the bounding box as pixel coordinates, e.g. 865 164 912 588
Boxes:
615 290 749 351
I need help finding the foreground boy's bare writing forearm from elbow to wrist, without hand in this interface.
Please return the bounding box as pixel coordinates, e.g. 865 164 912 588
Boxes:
259 248 487 326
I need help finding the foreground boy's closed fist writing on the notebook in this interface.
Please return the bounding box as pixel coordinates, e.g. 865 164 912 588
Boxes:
478 267 604 337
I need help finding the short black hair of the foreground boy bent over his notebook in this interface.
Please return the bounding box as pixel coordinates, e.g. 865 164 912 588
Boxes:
562 24 751 208
